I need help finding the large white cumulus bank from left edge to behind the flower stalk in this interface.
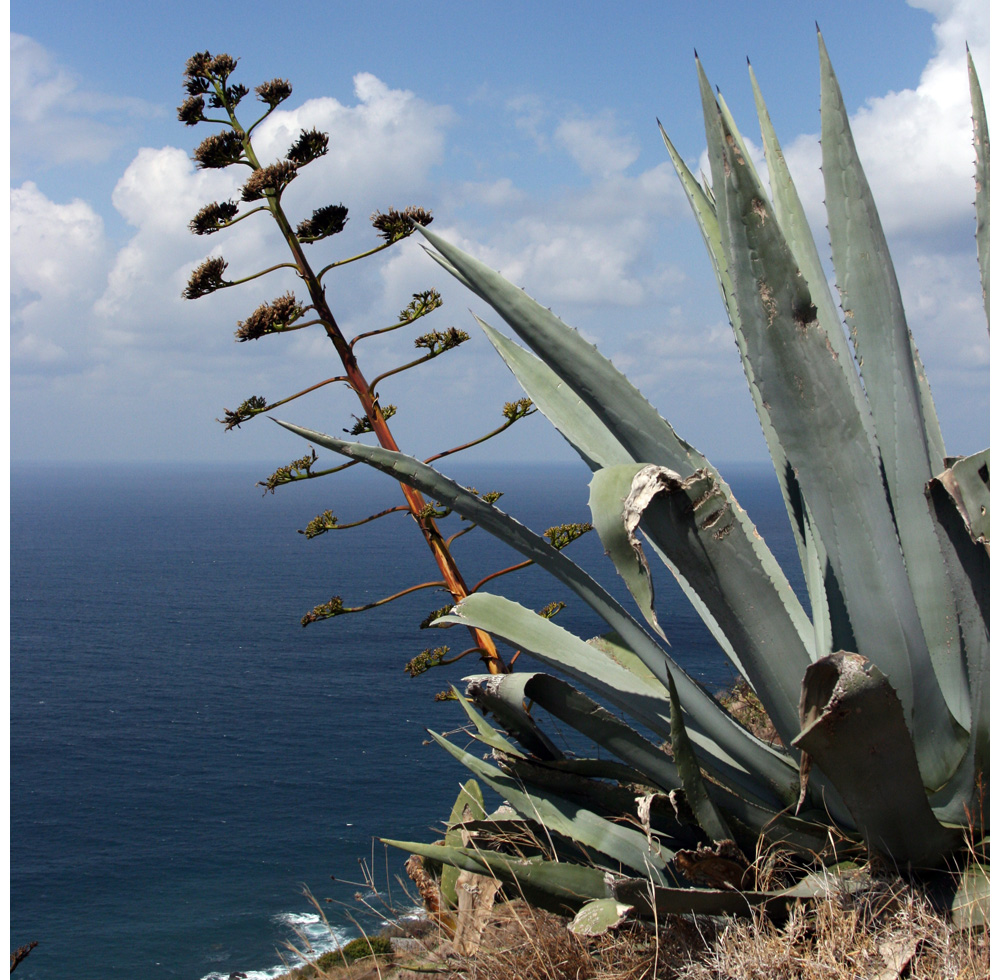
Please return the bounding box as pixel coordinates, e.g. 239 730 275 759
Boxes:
12 73 464 455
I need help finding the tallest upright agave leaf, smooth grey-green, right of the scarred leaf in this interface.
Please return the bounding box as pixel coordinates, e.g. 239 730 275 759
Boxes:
819 36 970 728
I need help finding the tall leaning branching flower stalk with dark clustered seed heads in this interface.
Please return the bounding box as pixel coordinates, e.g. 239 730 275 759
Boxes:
178 52 527 674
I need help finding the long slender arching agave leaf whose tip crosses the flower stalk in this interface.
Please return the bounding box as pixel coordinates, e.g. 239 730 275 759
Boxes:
276 420 795 806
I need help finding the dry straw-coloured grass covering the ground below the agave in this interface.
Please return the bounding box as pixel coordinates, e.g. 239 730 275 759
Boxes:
274 864 989 980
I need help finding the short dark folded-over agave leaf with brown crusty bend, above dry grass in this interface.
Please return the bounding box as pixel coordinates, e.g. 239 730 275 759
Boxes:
795 653 961 867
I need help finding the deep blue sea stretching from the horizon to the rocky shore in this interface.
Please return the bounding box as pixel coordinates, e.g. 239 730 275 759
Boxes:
10 464 794 980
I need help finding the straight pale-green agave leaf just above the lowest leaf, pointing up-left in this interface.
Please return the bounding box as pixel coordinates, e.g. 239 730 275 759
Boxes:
430 732 670 884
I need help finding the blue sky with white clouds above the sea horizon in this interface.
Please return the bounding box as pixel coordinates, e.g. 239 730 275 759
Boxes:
11 0 989 466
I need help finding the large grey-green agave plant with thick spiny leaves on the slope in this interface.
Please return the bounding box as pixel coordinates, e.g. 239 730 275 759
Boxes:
278 38 989 922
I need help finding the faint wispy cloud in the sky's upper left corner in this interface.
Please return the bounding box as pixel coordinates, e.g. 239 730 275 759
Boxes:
10 33 160 173
